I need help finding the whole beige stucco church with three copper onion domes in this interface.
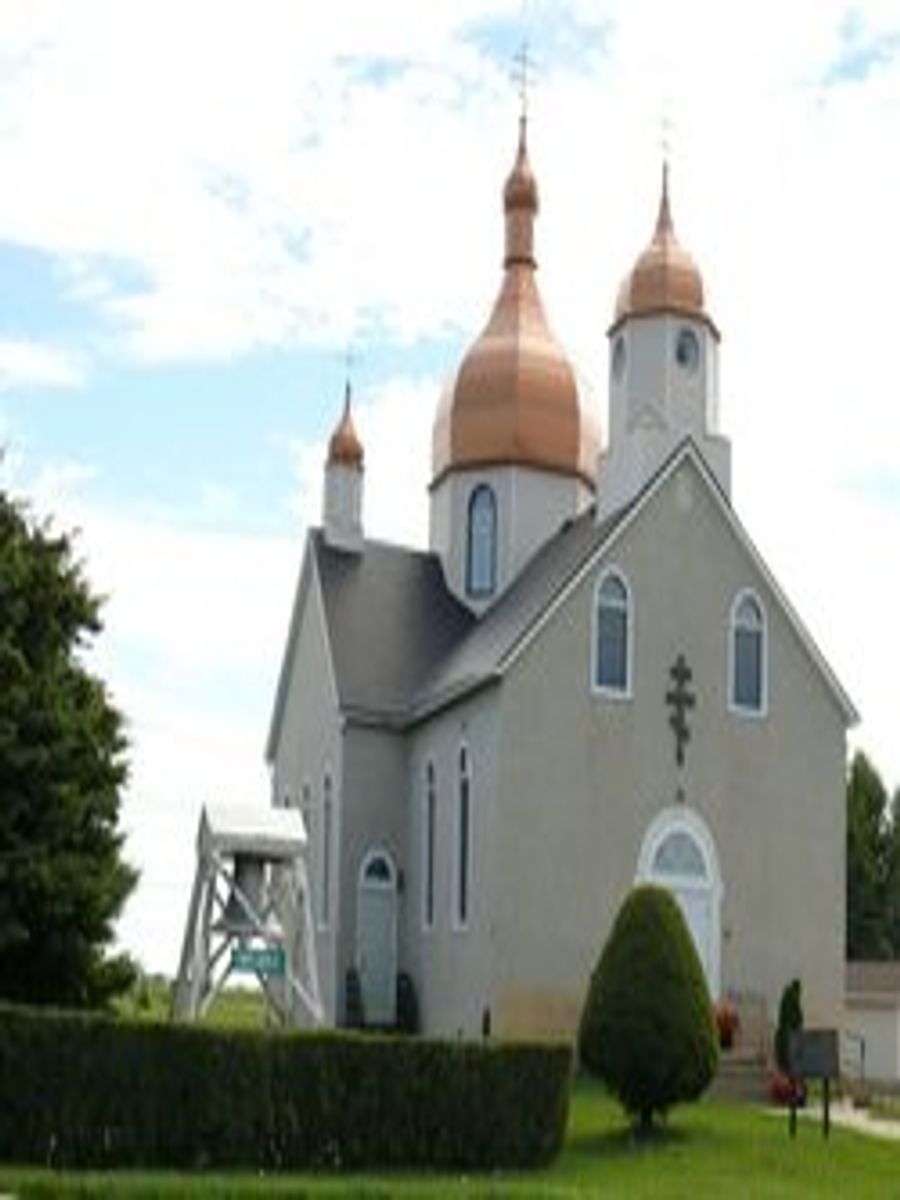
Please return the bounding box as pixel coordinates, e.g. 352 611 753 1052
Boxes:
266 119 856 1037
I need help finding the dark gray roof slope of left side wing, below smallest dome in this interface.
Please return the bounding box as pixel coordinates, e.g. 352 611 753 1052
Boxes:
312 530 475 719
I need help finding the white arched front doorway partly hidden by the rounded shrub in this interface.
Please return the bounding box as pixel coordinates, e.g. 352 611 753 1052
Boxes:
637 805 722 1000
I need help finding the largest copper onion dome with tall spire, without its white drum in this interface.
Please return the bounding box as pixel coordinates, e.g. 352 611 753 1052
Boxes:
432 116 600 488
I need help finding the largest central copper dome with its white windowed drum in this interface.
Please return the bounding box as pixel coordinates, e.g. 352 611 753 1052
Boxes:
430 115 599 613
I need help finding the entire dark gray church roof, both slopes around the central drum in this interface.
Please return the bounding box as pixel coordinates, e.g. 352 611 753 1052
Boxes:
313 509 625 722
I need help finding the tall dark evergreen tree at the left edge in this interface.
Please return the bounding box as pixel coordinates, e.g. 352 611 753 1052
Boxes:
0 488 137 1007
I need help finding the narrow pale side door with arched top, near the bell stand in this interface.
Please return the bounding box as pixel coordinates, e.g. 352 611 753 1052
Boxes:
356 851 397 1025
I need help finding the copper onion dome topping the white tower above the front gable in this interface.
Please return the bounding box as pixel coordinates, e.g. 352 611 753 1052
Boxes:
613 163 715 329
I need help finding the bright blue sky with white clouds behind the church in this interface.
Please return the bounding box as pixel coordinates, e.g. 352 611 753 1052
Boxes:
0 0 900 974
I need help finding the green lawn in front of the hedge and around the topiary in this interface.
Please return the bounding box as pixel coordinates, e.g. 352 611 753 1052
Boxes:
0 1080 900 1200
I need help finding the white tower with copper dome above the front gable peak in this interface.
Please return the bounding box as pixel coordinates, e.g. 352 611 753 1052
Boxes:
596 164 731 520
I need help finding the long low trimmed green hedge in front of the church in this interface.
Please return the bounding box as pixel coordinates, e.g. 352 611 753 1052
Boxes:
0 1006 571 1170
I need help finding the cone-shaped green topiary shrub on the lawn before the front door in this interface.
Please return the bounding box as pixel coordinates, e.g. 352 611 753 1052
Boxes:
578 886 719 1132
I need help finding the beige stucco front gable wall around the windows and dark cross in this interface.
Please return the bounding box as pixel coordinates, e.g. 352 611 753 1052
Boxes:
494 460 845 1033
